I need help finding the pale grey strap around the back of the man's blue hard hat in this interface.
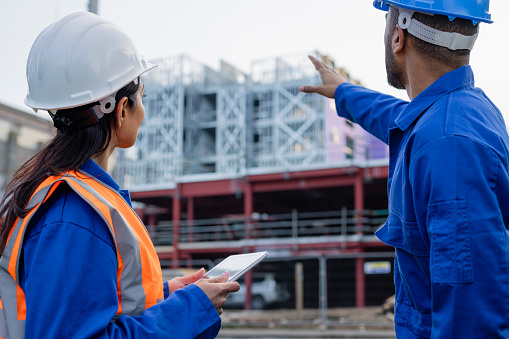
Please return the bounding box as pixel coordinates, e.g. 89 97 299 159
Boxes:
398 7 478 51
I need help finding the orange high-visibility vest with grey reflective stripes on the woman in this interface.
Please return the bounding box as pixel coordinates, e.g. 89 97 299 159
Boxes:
0 170 164 339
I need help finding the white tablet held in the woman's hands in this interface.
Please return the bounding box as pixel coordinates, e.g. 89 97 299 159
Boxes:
206 252 268 282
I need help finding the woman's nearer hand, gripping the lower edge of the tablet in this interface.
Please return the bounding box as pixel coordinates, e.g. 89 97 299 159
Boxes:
194 272 240 314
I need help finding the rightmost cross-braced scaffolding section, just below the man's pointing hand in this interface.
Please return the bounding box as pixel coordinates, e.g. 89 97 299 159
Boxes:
248 78 326 170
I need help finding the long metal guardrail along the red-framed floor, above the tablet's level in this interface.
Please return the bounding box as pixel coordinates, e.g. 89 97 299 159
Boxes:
148 208 388 246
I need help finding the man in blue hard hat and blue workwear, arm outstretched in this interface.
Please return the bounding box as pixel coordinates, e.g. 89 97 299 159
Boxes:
300 0 509 339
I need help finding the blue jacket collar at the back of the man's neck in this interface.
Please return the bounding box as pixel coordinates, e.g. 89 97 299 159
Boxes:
395 65 474 131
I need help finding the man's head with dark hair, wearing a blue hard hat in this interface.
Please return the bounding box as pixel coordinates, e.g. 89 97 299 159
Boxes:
374 0 491 89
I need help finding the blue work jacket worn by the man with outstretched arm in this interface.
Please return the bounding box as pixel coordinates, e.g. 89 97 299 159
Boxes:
335 66 509 339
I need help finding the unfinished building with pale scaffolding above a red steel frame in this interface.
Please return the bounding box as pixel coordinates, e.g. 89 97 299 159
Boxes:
114 52 394 308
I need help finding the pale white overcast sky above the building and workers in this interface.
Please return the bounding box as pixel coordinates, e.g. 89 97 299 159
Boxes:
0 0 509 123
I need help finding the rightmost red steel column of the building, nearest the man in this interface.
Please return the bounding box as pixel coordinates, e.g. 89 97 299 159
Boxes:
354 169 366 307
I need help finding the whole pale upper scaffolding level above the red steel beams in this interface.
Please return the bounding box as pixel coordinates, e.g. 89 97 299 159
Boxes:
114 52 386 190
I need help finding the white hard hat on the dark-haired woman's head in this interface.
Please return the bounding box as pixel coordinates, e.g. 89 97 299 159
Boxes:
25 12 156 113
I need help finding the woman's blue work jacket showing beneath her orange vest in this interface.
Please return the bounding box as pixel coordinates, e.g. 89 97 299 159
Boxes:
19 160 221 339
